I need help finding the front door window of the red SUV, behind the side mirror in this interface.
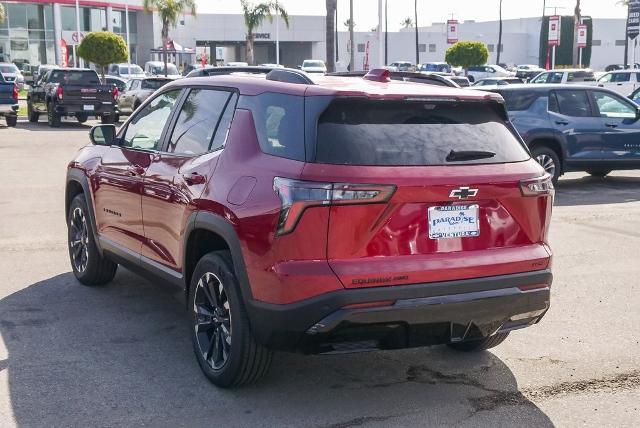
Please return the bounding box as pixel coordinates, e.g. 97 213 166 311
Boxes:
122 89 181 150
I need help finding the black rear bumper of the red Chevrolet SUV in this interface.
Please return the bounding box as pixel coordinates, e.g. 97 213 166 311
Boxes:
248 270 552 353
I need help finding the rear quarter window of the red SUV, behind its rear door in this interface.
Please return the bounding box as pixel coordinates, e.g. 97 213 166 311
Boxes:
241 93 305 161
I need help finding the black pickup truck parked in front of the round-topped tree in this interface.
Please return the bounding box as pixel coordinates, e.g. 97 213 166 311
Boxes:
27 68 118 127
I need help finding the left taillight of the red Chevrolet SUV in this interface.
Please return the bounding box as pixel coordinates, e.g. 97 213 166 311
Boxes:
273 177 396 235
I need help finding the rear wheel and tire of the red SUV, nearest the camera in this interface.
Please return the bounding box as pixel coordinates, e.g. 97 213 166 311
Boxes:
188 251 273 388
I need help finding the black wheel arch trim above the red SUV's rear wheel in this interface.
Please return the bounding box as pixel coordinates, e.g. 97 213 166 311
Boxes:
182 211 253 302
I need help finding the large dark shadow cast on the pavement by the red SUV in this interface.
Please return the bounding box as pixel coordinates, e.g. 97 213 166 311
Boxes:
0 269 553 427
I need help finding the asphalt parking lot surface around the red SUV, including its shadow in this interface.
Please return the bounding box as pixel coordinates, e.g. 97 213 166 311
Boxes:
0 121 640 427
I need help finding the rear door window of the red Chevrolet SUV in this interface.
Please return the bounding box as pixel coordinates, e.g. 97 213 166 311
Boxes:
167 89 231 155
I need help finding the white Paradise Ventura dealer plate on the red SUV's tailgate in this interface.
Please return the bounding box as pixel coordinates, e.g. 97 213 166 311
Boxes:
429 204 480 239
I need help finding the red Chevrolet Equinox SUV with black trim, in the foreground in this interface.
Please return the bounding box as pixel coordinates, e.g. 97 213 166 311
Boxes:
66 69 554 387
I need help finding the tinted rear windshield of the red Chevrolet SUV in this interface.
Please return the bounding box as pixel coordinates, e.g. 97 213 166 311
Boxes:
316 98 529 166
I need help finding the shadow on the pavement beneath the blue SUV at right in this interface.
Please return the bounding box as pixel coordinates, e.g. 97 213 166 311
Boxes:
554 176 640 206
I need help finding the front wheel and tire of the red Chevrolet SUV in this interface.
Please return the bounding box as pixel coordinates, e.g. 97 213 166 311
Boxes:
67 194 118 286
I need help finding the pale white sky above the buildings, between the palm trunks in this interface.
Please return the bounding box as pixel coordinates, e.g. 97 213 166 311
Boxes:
196 0 626 31
